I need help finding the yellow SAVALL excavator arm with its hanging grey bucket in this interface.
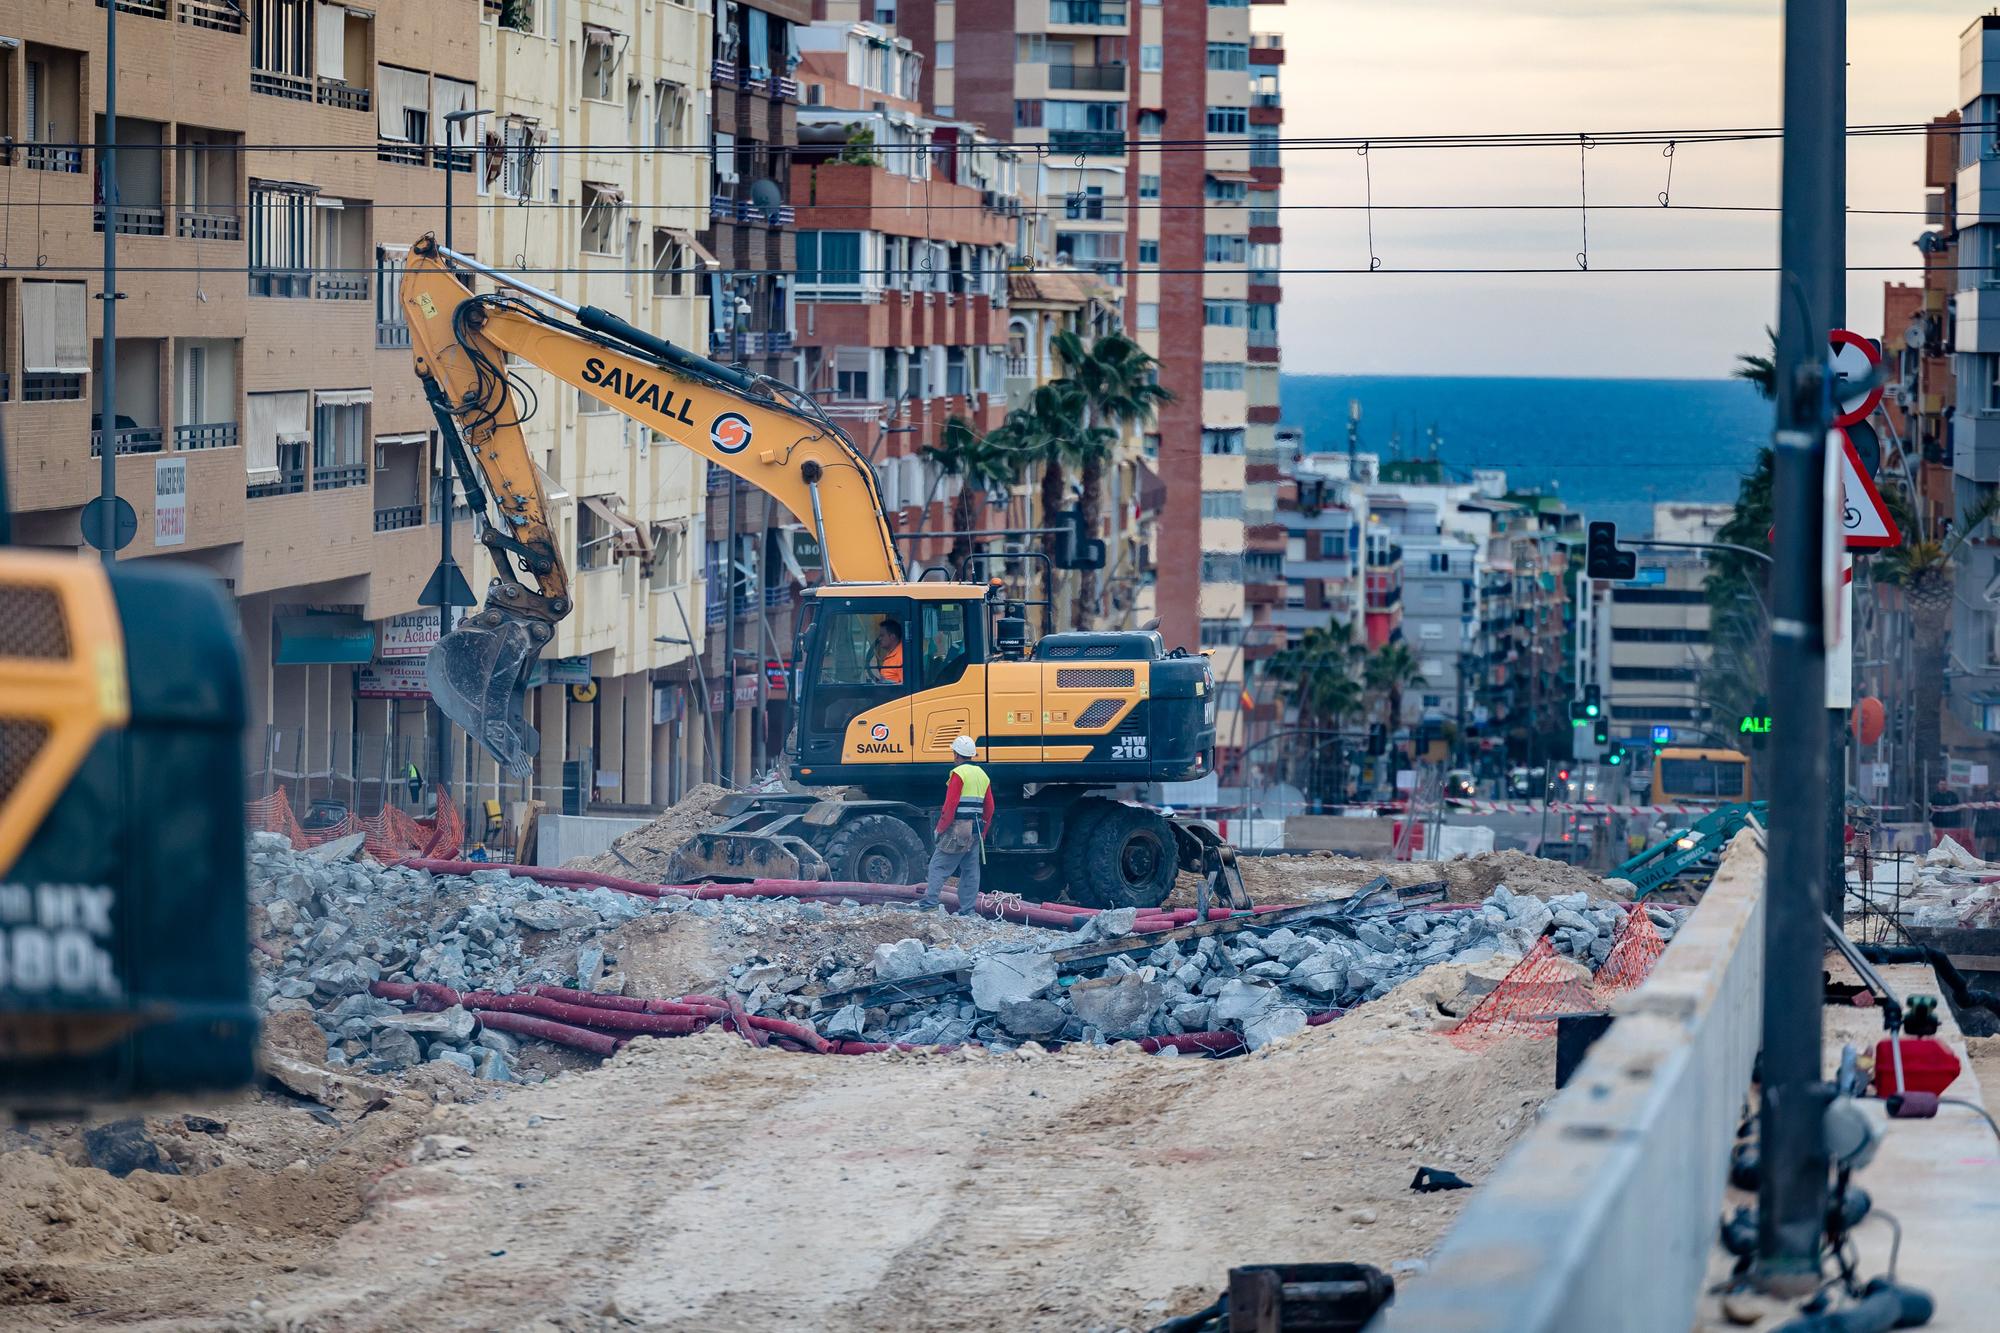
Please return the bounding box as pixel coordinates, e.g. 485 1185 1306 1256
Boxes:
402 236 904 773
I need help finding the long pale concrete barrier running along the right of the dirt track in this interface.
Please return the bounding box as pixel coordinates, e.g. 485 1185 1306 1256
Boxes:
1370 831 1764 1333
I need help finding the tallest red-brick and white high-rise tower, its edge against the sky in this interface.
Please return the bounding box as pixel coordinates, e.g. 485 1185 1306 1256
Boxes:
900 0 1286 763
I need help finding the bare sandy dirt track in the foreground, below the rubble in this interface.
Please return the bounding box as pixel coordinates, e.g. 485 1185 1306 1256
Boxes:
0 969 1554 1333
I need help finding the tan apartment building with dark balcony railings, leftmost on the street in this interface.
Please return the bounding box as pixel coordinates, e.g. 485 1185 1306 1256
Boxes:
0 0 478 811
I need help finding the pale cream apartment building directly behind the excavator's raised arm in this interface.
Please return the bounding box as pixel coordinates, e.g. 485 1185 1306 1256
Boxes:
472 0 714 811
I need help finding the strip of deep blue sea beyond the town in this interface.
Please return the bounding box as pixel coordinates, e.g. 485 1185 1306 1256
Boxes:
1280 374 1772 534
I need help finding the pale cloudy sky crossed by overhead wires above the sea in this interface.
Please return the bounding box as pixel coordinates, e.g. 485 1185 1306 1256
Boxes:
1252 0 1984 378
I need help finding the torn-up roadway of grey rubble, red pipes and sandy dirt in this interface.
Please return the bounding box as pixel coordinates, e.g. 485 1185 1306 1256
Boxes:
0 772 1682 1329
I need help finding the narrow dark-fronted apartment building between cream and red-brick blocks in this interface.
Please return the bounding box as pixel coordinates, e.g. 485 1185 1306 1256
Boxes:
686 0 812 779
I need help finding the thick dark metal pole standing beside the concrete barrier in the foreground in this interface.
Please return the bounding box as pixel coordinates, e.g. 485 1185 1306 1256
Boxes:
1756 0 1846 1295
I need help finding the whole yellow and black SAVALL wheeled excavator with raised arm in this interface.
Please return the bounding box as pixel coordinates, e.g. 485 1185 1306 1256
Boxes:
402 236 1242 907
